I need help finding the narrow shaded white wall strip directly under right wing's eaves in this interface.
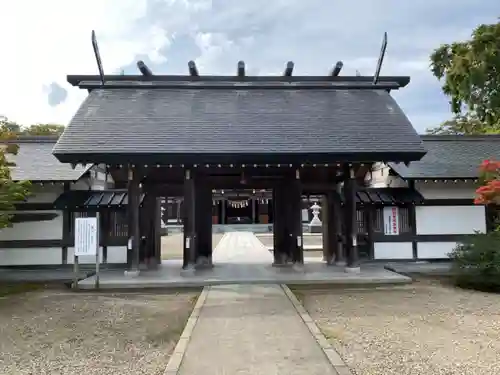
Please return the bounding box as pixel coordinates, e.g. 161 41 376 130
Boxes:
415 180 476 199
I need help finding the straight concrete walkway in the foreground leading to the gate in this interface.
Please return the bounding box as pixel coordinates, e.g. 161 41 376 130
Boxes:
178 285 338 375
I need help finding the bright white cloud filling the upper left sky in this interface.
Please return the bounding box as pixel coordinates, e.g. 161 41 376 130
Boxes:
0 0 166 124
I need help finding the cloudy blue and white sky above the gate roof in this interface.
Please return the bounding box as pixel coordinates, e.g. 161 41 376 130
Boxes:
0 0 500 133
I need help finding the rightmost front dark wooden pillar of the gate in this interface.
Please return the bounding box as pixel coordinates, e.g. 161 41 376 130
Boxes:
344 167 360 272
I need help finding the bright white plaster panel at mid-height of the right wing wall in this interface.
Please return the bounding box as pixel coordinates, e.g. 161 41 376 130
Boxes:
416 205 486 234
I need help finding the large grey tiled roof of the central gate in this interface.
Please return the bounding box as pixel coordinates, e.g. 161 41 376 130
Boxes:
54 84 425 162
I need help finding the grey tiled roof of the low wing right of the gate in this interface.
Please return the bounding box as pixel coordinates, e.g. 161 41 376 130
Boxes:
389 135 500 179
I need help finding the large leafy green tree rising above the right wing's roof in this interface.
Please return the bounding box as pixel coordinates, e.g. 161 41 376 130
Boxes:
429 22 500 134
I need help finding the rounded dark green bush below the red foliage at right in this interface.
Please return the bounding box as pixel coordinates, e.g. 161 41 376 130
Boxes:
450 231 500 293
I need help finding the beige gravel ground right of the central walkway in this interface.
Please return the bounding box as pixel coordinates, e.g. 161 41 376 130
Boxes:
297 279 500 375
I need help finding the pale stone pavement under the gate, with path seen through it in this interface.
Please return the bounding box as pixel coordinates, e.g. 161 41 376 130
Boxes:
78 232 411 289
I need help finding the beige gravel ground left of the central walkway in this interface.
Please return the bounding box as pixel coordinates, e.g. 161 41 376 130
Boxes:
0 289 198 375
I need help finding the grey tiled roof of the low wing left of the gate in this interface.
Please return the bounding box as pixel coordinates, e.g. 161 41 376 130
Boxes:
7 136 90 181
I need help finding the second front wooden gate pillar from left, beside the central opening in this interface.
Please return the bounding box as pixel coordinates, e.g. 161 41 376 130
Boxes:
182 169 196 269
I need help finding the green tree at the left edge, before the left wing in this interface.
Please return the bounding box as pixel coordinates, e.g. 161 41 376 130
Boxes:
0 120 30 229
